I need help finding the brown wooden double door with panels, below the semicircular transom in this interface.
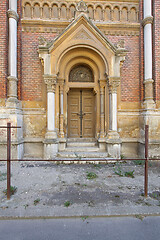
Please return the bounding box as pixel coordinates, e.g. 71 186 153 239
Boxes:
68 89 96 138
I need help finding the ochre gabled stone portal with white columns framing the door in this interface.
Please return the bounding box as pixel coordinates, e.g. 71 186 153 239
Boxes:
39 14 126 157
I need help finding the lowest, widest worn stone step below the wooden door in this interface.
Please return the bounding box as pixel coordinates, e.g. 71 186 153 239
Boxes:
57 151 108 159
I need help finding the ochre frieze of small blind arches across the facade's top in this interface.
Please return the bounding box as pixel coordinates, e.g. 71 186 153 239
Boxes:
22 0 139 22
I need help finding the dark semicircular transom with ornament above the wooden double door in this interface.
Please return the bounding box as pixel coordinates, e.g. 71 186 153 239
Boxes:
69 65 94 82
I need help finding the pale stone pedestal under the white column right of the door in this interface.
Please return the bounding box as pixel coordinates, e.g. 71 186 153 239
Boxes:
106 131 122 159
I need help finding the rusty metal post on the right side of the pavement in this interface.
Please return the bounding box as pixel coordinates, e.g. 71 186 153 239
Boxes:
144 125 149 197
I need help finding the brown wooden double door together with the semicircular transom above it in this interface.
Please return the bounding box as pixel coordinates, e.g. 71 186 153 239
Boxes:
67 64 95 138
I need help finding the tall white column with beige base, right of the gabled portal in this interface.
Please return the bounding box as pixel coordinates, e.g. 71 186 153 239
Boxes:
142 0 155 109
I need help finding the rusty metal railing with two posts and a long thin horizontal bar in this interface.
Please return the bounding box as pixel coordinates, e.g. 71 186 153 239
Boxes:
0 123 160 200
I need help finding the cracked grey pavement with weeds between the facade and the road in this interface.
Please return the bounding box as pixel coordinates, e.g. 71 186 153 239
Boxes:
0 161 160 218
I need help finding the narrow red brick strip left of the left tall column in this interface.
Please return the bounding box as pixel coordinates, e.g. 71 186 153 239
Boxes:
0 0 8 98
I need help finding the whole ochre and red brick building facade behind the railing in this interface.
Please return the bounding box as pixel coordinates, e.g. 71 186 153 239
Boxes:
0 0 160 159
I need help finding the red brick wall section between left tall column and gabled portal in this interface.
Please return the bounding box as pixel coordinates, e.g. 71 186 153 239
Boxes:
22 32 55 101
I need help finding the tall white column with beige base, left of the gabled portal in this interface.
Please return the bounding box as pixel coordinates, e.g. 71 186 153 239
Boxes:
7 0 19 104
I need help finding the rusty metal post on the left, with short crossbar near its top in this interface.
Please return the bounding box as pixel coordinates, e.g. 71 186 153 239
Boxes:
7 123 11 200
